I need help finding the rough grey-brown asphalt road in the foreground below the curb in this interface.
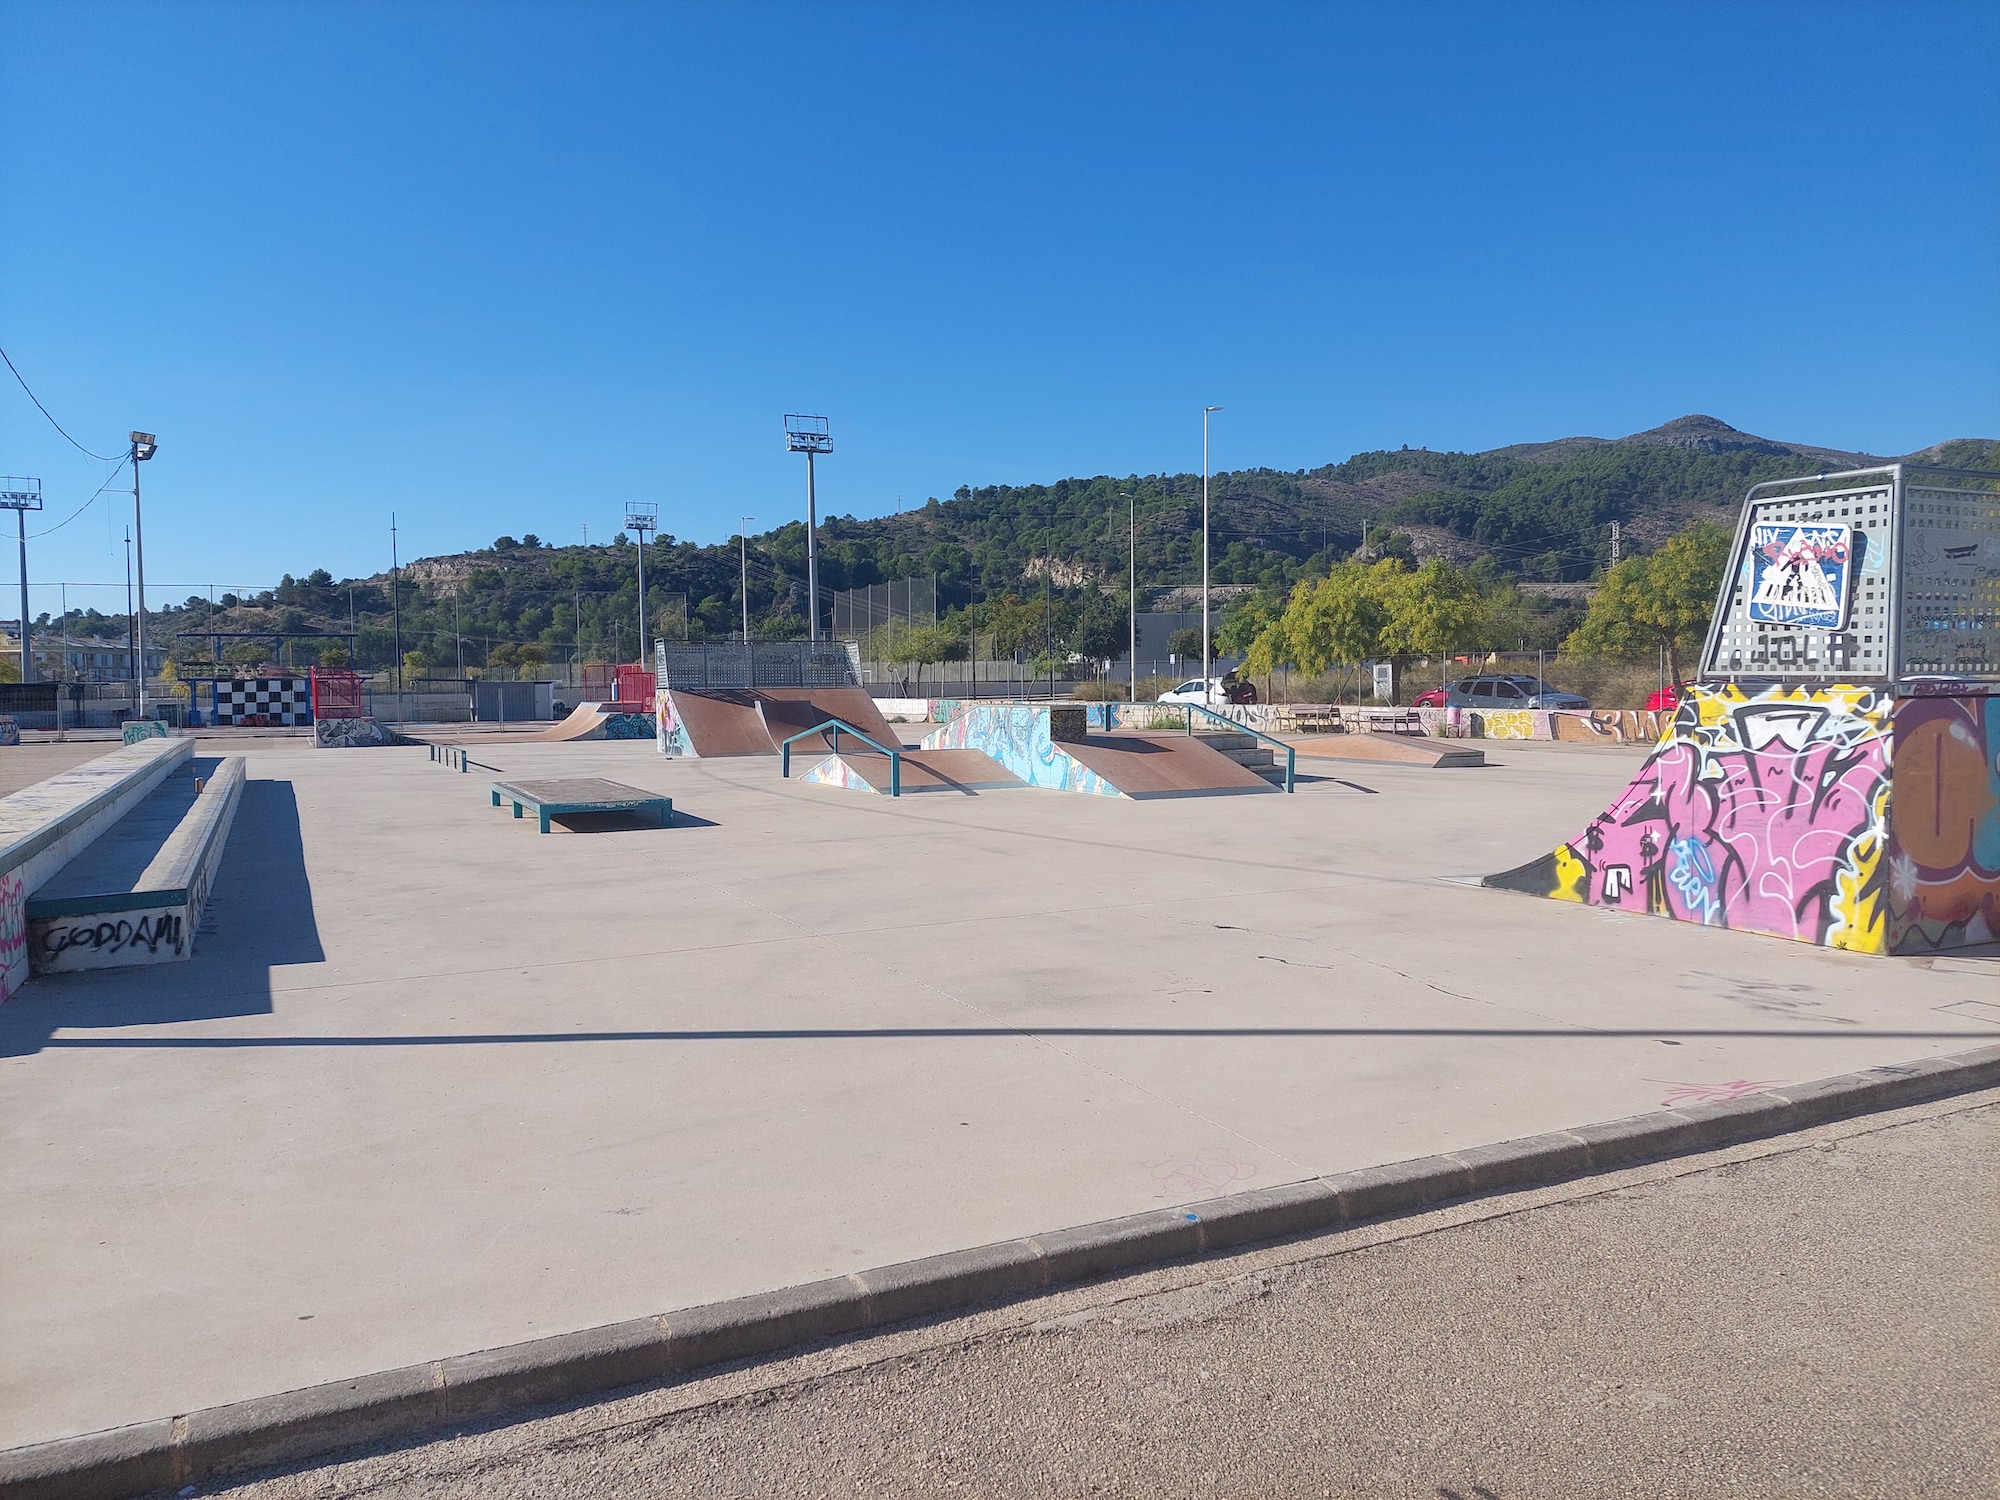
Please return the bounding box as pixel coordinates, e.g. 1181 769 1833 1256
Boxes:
211 1094 2000 1500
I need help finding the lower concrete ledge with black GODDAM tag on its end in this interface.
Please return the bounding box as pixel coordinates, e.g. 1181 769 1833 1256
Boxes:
28 756 244 974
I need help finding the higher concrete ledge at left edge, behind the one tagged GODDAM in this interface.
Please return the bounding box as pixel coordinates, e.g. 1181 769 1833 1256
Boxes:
0 738 194 1000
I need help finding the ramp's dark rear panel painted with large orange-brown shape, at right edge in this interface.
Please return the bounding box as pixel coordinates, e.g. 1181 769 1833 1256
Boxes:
1888 698 2000 954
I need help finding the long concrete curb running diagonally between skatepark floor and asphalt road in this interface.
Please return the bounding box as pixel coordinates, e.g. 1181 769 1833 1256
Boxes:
0 1046 2000 1500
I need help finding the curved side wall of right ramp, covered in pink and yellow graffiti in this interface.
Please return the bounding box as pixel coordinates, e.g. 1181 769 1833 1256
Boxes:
1486 686 1892 952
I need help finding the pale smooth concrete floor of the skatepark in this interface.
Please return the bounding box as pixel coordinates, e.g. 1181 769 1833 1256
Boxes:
0 740 2000 1444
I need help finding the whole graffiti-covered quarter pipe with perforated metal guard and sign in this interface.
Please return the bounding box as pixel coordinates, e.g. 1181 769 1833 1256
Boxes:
1484 464 2000 954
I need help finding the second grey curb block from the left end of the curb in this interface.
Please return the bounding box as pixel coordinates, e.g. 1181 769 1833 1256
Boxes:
182 1364 444 1482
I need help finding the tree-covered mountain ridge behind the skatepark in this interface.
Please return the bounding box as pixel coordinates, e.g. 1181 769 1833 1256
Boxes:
86 416 2000 670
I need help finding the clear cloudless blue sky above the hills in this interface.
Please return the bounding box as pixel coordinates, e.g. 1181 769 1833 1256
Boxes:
0 0 2000 614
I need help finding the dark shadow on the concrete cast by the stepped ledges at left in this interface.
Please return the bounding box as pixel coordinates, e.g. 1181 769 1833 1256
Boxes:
0 780 326 1056
